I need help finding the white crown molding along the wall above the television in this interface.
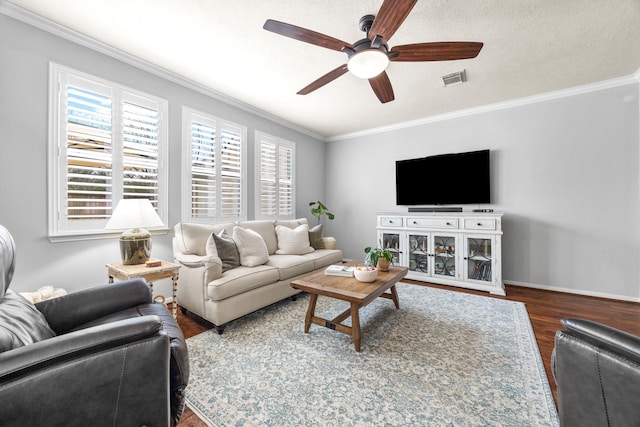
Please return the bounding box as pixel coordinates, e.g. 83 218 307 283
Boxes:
325 69 640 142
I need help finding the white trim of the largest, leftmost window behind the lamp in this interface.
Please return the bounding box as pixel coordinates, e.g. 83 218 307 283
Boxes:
47 62 169 242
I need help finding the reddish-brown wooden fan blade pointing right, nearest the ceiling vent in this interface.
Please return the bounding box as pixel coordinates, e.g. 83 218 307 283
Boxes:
389 42 483 62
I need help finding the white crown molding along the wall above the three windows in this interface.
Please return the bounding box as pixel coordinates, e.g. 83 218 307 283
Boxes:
0 0 325 141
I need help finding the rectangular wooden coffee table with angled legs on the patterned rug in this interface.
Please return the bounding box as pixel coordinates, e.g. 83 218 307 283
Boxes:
291 263 409 352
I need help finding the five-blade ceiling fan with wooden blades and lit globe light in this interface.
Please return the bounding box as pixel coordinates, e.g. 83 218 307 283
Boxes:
263 0 483 103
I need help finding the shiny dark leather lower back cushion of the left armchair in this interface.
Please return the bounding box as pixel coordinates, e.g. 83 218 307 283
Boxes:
0 290 56 353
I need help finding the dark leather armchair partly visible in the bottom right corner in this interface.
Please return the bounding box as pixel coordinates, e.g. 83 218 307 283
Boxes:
551 318 640 427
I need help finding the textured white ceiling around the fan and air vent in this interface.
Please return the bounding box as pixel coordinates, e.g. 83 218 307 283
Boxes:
7 0 640 137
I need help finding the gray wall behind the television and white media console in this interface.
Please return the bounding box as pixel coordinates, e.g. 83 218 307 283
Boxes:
327 83 640 301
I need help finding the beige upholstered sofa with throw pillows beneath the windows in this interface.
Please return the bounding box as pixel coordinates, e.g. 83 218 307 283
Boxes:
173 218 342 334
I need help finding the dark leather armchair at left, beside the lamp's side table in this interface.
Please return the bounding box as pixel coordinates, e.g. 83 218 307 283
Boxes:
0 226 189 426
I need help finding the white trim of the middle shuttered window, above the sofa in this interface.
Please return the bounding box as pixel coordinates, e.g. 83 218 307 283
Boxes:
181 106 247 223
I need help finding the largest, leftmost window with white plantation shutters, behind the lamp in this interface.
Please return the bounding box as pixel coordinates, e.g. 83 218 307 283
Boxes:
49 64 167 241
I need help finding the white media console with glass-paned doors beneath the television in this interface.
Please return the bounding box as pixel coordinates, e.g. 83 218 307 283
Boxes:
377 212 505 295
